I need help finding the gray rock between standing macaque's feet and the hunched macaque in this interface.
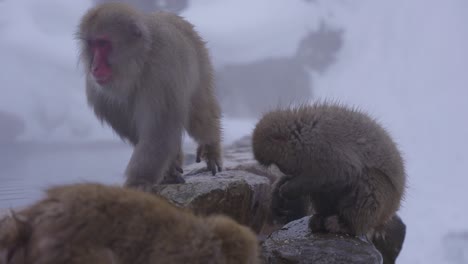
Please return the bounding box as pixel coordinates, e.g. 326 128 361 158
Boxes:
154 170 270 232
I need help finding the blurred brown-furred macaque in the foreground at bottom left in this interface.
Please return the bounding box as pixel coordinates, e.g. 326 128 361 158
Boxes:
0 184 258 264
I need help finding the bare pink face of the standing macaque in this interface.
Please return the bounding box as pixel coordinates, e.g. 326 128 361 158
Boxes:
88 37 112 85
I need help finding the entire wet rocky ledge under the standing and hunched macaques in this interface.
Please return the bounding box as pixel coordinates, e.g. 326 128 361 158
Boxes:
0 137 402 264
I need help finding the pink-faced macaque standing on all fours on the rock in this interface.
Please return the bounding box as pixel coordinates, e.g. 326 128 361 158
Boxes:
76 3 222 189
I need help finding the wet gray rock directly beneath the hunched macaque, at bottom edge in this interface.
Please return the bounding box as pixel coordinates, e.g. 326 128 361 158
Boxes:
263 217 382 264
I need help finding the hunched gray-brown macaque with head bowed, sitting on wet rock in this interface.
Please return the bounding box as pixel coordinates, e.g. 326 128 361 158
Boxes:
253 103 406 236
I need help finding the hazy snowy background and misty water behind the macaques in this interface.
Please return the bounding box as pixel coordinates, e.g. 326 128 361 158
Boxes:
0 0 468 263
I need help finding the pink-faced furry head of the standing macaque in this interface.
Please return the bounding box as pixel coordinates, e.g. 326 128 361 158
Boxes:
77 3 151 90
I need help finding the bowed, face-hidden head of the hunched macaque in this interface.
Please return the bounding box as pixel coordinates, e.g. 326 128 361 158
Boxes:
252 110 304 175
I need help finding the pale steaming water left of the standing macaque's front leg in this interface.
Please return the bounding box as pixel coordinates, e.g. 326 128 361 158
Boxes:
0 143 131 209
